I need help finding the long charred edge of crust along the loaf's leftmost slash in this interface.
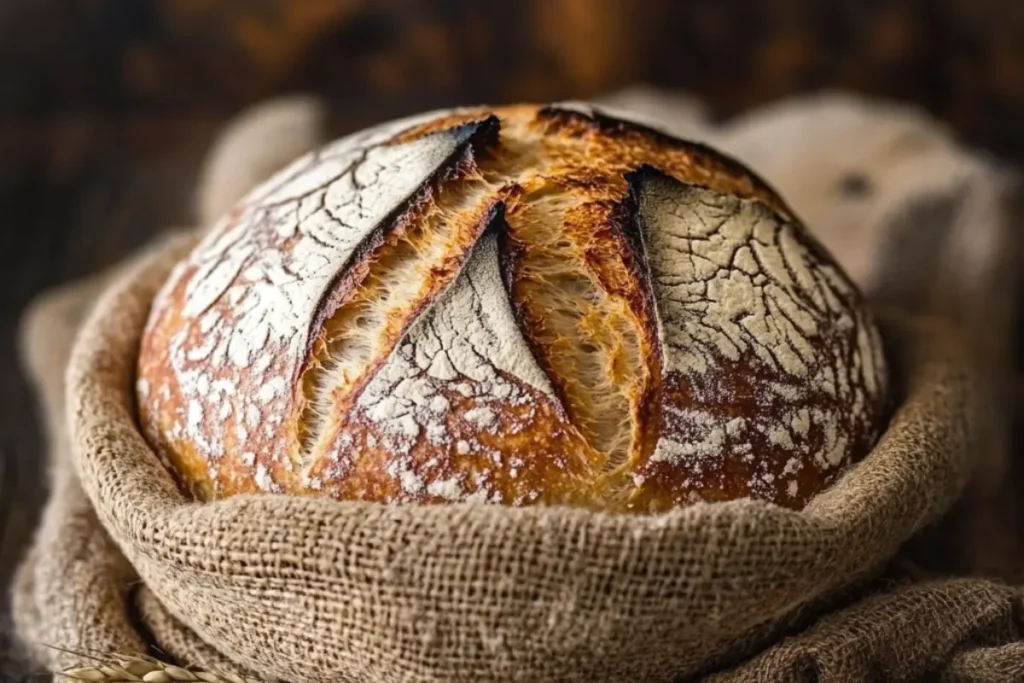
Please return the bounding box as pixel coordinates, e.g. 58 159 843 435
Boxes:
292 115 501 382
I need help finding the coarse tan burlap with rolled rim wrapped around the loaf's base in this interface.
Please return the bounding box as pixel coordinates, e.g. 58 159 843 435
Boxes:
68 228 973 682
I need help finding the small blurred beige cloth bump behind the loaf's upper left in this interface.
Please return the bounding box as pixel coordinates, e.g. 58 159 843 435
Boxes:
195 95 327 231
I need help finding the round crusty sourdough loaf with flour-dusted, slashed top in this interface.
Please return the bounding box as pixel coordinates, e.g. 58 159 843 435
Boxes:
137 102 887 513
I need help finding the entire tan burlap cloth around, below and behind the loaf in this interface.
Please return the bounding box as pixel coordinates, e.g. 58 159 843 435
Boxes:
13 90 1024 683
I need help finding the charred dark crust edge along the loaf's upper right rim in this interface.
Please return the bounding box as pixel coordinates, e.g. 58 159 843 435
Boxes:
537 104 796 216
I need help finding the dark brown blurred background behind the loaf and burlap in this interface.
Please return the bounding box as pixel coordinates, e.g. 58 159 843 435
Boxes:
0 0 1024 679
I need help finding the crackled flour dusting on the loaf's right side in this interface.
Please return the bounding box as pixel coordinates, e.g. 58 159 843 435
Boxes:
626 172 883 507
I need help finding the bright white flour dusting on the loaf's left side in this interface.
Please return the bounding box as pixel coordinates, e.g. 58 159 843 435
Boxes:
136 112 479 492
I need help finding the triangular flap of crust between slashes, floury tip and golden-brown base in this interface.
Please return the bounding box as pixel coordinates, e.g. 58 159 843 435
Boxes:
314 230 595 505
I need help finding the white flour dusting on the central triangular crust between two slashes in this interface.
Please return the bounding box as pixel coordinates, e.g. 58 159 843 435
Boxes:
317 230 558 502
